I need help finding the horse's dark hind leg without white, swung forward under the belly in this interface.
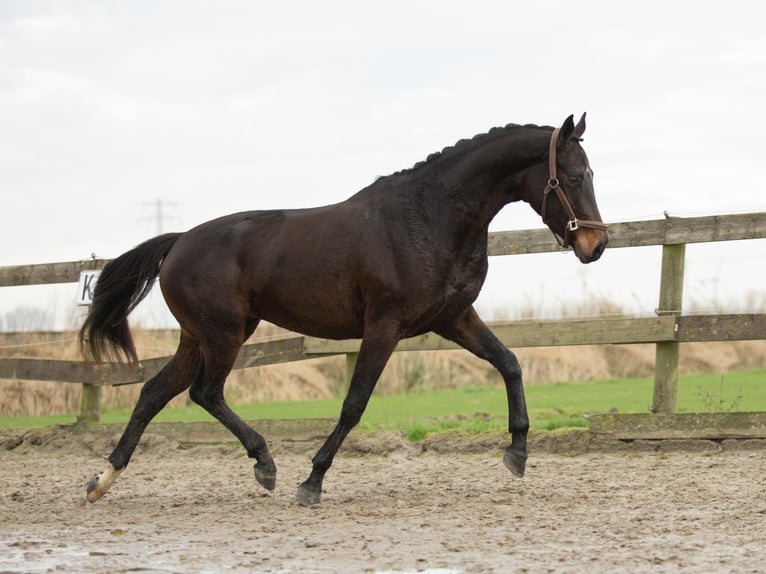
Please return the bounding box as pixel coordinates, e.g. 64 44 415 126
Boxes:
189 328 277 490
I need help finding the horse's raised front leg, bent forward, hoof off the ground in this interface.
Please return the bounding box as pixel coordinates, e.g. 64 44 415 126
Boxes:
435 307 529 477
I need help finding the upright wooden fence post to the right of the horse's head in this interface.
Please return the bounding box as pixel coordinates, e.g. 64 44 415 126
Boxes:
652 243 686 414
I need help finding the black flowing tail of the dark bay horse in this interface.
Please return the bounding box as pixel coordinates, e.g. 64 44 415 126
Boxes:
80 233 181 364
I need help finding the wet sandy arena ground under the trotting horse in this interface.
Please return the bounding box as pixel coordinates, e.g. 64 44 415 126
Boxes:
0 430 766 574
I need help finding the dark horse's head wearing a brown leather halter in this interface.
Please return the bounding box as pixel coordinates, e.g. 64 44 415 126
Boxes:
525 114 608 263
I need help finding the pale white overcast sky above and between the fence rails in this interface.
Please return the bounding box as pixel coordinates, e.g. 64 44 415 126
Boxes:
0 0 766 330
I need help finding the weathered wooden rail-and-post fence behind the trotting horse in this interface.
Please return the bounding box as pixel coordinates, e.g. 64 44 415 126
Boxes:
0 212 766 438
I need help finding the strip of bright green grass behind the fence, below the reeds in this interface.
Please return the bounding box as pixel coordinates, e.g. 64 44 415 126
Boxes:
6 370 766 440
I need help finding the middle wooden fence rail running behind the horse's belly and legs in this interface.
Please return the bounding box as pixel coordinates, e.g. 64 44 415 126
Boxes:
0 313 766 386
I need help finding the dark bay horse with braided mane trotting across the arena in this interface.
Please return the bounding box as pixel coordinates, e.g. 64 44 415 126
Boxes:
80 114 607 506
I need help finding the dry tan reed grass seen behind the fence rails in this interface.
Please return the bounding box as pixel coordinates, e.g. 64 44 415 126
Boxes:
0 326 766 416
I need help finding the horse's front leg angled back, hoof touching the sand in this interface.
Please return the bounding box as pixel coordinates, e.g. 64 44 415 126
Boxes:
298 321 399 506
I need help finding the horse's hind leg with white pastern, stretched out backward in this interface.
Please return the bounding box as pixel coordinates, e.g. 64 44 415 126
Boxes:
87 334 200 502
